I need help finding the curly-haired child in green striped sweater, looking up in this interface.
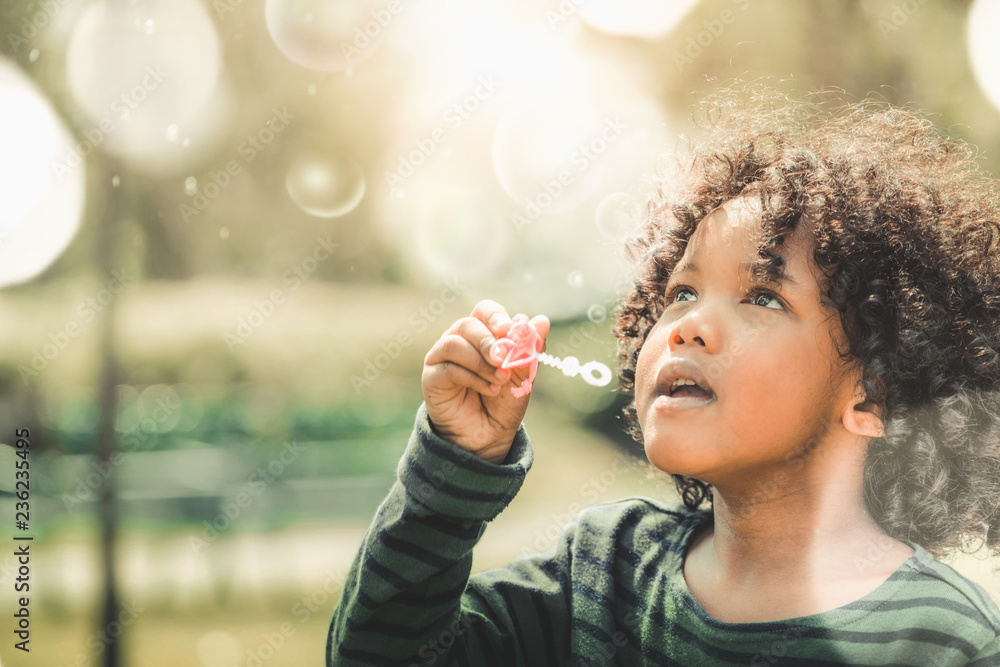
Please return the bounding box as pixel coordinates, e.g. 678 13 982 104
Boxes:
327 92 1000 667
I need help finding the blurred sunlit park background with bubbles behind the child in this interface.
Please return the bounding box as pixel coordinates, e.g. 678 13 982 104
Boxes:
0 0 1000 667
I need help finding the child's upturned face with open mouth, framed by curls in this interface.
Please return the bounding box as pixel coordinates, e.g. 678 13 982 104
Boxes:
635 200 853 487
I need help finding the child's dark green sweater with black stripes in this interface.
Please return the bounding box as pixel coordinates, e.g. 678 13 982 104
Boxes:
327 406 1000 667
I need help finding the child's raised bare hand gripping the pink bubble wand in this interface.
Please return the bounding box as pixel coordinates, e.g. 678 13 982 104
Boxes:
421 300 549 463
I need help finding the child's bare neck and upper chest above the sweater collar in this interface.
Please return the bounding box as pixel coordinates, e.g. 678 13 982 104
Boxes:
684 452 913 622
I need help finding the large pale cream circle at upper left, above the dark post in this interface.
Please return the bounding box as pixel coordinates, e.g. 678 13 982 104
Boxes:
66 0 222 171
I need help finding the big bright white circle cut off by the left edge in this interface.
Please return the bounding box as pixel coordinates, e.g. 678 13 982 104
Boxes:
0 58 85 285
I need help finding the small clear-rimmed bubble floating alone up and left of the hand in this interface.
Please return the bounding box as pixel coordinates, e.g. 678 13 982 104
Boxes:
285 155 365 218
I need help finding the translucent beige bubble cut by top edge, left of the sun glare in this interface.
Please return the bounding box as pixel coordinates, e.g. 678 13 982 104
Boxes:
264 0 398 72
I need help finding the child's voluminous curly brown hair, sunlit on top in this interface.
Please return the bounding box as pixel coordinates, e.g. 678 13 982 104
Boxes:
614 85 1000 557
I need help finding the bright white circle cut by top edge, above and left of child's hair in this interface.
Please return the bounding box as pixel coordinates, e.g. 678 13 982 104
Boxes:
579 0 698 39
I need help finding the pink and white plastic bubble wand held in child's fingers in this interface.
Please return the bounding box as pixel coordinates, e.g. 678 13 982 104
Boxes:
490 314 611 398
